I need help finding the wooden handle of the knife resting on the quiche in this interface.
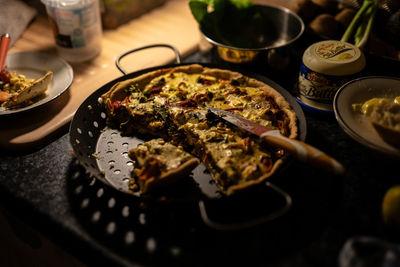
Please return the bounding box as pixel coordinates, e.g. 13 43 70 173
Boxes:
261 130 344 174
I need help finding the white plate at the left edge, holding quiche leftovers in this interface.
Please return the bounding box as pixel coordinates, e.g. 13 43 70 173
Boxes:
0 52 74 115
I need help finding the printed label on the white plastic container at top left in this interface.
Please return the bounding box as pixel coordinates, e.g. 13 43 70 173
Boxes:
49 3 101 48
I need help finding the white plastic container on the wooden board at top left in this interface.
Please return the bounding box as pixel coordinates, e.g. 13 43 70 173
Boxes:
41 0 102 62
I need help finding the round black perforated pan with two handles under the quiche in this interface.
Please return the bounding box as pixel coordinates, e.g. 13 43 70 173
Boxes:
69 45 306 230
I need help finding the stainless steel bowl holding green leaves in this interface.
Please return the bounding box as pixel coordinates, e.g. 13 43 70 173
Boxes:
200 5 305 63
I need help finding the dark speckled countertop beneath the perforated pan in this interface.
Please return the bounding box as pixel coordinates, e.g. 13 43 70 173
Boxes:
0 44 400 266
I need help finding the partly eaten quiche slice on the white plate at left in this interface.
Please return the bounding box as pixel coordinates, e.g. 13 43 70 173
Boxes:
0 69 53 108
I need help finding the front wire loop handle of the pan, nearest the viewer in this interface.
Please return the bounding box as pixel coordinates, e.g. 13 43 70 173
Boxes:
199 182 292 230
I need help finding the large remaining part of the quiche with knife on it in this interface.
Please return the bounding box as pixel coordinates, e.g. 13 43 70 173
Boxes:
102 64 298 195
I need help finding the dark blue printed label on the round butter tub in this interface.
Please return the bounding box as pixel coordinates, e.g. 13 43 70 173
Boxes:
298 63 350 110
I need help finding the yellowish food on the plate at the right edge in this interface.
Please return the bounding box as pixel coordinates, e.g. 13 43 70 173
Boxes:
353 96 400 147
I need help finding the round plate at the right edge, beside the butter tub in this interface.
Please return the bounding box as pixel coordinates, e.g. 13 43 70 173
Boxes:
333 76 400 157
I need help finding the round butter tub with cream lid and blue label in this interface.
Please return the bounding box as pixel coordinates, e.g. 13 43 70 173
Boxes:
297 40 366 111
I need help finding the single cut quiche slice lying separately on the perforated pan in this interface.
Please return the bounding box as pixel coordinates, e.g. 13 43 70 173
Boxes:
129 138 200 193
